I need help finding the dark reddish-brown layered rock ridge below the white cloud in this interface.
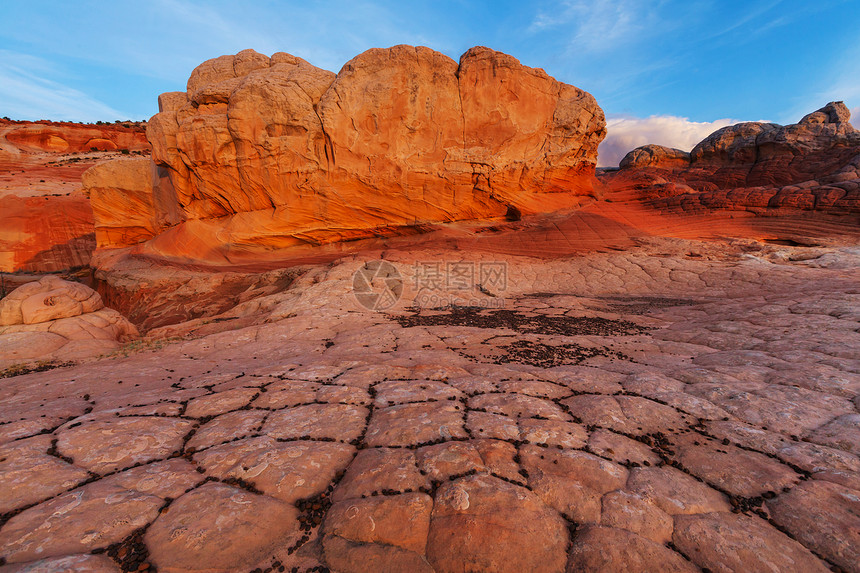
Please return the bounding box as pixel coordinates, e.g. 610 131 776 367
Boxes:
602 102 860 214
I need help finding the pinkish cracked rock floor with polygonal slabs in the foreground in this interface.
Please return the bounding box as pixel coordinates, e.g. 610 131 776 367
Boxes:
0 235 860 572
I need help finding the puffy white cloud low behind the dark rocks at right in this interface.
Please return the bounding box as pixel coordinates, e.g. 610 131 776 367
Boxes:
597 115 738 167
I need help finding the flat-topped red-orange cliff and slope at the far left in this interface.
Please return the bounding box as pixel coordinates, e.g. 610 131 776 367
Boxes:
0 119 150 272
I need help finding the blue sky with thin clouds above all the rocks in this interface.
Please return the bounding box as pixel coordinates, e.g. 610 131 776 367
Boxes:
0 0 860 163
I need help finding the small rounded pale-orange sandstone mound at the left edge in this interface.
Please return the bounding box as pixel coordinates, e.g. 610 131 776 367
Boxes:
0 276 138 366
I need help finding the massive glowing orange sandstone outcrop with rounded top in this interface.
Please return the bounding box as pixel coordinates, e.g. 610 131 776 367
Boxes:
84 46 605 263
